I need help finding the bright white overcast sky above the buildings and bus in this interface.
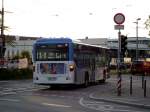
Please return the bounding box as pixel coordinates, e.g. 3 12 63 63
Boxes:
0 0 150 39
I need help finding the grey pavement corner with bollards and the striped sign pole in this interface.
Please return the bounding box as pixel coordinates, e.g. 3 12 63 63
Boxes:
90 75 150 109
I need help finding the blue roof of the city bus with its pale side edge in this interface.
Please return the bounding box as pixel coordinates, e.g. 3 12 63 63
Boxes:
35 38 109 49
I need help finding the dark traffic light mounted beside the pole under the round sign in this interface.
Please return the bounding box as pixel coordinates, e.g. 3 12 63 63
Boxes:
121 35 127 57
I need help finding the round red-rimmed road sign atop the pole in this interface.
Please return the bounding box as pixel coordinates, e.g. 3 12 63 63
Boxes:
114 13 125 24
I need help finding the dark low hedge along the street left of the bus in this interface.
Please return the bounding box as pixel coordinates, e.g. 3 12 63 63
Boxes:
0 68 33 80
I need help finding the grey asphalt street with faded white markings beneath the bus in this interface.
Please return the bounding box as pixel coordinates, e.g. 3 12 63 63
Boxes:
0 76 149 112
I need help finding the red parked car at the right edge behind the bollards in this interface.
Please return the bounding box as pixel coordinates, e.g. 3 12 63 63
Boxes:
131 60 150 75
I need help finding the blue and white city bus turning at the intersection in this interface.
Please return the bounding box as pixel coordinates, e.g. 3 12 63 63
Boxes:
32 38 109 87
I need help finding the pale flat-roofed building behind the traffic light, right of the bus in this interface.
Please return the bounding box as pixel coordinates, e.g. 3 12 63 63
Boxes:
80 37 150 60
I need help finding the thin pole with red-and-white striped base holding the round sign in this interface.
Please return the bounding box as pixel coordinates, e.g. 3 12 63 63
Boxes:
117 29 121 96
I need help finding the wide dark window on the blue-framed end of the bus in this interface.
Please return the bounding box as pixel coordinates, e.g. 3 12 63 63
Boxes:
36 44 69 61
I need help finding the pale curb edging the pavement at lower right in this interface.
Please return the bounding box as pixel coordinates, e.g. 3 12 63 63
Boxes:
89 94 150 109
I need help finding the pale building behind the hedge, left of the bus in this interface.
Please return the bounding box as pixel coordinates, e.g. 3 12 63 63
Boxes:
5 35 38 59
